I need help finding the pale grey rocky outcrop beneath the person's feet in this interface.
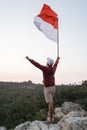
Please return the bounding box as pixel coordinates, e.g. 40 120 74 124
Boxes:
14 102 87 130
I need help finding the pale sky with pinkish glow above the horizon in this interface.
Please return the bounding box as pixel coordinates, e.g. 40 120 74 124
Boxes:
0 0 87 84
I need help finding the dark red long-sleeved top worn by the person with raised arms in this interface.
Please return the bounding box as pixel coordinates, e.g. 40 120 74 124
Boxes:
29 59 58 87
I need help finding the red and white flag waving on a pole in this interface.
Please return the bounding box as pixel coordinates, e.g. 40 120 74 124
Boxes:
34 4 58 42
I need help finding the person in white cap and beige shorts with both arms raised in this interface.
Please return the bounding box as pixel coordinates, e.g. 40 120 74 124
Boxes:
26 56 60 122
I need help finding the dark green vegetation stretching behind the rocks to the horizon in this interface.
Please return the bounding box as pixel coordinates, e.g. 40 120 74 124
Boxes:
0 81 87 129
